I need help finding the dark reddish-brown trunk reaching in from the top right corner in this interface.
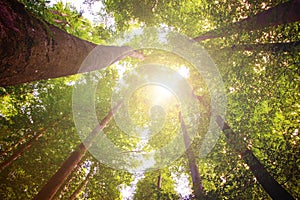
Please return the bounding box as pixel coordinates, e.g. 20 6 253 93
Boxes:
194 0 300 42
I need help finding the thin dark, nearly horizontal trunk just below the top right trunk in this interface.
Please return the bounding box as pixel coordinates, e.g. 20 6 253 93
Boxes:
220 41 300 52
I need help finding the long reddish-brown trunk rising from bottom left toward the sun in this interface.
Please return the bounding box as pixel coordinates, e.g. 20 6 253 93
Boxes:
34 101 123 200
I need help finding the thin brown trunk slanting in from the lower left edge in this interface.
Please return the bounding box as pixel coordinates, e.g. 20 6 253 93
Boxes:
0 121 58 171
